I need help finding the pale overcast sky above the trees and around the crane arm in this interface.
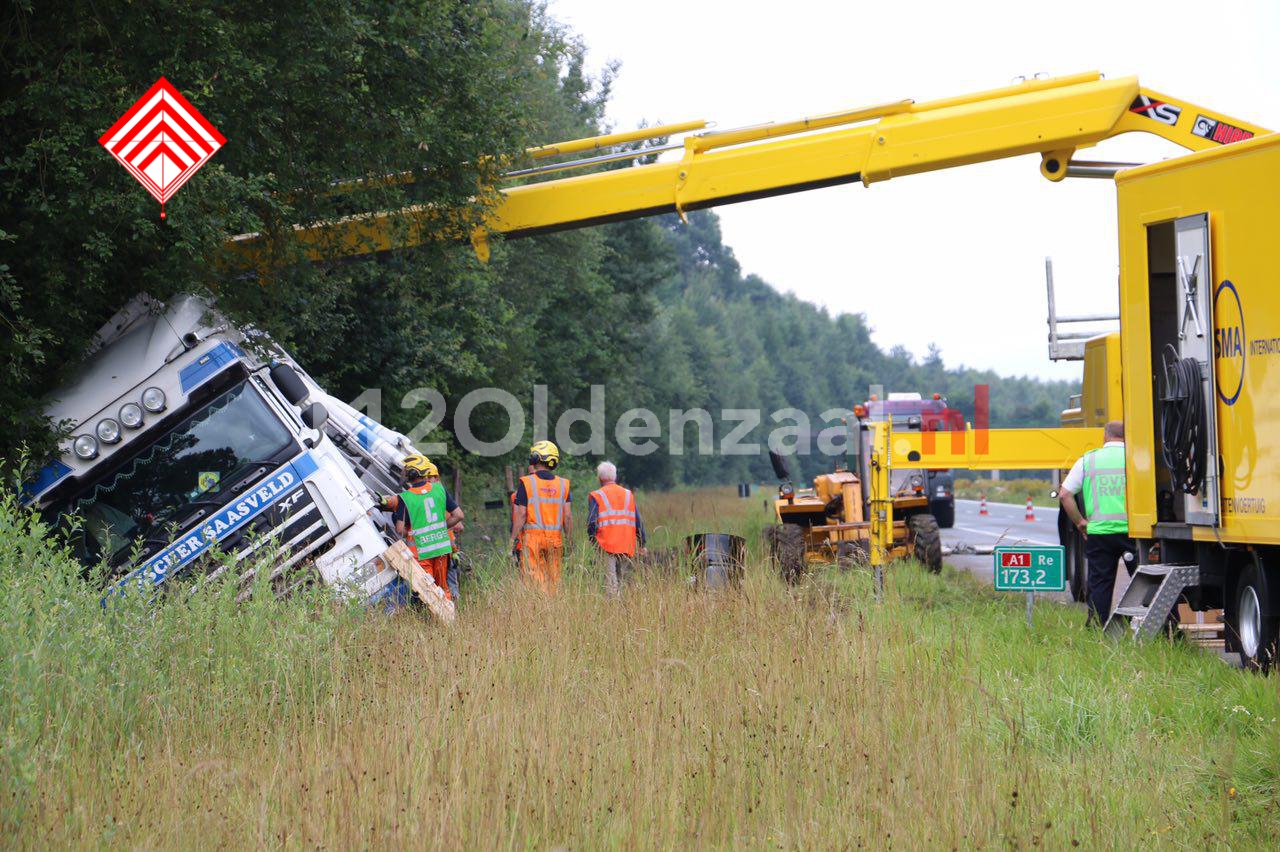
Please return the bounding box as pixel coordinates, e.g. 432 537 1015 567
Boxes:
549 0 1280 379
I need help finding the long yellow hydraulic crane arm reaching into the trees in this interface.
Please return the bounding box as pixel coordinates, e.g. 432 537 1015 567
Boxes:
232 72 1268 266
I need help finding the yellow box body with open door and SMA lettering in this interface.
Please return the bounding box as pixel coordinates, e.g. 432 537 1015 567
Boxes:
1116 136 1280 545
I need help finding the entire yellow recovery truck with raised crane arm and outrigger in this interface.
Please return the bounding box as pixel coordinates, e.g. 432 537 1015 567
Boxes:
230 72 1280 668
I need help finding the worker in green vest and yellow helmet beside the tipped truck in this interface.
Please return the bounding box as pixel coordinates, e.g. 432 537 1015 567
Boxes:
392 454 462 600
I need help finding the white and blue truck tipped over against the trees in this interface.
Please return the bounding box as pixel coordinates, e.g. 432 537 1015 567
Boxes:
26 296 416 606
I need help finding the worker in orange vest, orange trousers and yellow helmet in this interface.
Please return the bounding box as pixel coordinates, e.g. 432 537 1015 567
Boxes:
511 441 573 594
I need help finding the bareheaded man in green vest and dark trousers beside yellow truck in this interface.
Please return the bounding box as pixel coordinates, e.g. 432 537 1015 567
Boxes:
1059 420 1138 624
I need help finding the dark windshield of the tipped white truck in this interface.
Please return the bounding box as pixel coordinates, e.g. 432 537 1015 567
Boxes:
52 383 292 567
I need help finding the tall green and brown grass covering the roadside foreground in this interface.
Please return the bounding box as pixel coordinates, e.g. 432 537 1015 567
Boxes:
0 483 1280 848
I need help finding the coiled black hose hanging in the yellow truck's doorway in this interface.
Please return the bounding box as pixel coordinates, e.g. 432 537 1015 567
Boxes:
1160 345 1208 494
